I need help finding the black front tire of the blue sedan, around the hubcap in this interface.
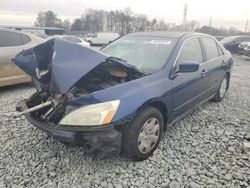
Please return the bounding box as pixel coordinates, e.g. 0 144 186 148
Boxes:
122 107 164 161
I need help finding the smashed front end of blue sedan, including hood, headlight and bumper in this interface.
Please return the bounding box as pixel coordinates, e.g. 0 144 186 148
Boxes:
12 39 143 157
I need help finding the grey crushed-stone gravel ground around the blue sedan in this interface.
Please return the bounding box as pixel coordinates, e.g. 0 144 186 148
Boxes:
0 57 250 188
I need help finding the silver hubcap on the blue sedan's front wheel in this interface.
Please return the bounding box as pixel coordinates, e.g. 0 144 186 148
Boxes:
137 118 160 154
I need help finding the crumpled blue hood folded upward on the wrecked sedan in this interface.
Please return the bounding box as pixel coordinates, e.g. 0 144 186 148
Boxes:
12 39 108 93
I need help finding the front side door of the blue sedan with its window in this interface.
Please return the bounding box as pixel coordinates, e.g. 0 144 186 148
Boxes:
172 38 208 118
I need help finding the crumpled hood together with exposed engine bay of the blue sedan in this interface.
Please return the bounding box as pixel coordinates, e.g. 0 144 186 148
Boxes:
12 40 144 124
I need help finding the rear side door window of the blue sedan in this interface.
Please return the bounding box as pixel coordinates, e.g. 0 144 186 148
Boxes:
201 38 220 61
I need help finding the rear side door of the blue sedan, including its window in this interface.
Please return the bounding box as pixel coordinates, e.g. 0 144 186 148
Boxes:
201 37 227 95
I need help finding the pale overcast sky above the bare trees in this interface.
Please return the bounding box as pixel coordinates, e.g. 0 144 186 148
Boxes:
0 0 250 30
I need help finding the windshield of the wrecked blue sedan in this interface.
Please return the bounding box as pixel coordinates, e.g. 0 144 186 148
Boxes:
101 37 177 74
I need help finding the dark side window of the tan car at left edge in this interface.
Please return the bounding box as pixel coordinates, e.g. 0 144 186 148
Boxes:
0 31 23 47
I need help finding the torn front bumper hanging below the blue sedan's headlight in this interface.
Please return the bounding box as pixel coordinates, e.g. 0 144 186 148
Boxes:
17 101 122 158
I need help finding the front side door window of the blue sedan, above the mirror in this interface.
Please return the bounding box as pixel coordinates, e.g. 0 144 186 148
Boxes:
174 38 203 72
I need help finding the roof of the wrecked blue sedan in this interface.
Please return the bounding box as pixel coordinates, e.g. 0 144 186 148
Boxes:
127 31 209 39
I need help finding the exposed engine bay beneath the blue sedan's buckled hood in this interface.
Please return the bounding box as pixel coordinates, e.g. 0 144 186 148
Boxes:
26 60 142 124
